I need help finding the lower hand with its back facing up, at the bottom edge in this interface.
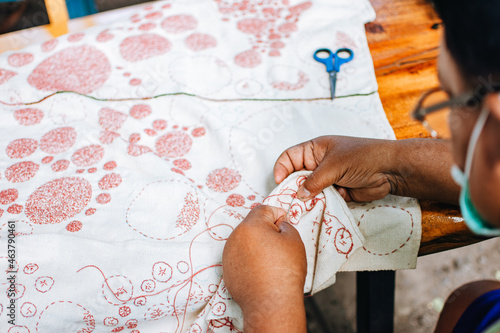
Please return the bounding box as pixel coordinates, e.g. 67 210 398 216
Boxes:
222 206 307 333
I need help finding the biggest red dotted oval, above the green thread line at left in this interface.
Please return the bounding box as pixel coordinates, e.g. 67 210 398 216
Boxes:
28 45 111 94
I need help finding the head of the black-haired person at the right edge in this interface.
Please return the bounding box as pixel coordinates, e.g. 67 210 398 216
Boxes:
433 0 500 227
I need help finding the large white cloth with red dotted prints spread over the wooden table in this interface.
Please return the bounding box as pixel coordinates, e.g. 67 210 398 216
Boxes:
0 0 420 333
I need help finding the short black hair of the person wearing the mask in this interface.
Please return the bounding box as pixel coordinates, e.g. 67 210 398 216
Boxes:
431 0 500 85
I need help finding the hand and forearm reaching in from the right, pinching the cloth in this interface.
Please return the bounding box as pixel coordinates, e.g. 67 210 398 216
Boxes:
274 136 460 204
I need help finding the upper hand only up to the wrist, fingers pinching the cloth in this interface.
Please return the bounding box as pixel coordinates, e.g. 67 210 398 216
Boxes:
274 136 393 201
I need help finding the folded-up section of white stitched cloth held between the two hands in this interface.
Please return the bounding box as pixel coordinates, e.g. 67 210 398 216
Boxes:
263 171 365 294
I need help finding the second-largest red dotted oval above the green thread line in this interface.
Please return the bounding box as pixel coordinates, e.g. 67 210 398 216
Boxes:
120 34 172 62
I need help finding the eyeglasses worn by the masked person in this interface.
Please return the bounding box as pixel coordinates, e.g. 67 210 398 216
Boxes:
411 88 481 139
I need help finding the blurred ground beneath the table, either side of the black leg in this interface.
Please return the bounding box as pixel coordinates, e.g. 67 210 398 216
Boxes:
306 238 500 333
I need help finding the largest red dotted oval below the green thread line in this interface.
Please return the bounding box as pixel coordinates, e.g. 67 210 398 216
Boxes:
25 177 92 224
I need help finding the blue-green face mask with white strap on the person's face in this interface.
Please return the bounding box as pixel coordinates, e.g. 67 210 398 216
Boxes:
451 109 500 236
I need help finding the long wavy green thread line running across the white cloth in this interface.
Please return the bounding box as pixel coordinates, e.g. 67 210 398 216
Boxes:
4 90 377 105
